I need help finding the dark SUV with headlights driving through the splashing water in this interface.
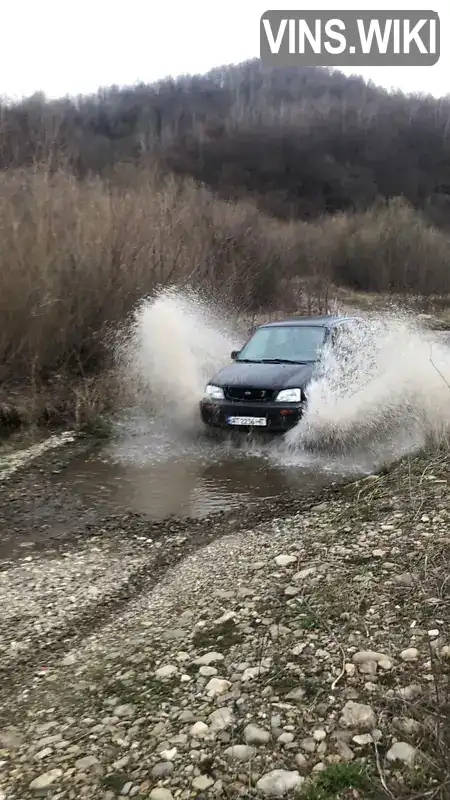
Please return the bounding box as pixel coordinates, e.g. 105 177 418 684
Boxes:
200 316 361 433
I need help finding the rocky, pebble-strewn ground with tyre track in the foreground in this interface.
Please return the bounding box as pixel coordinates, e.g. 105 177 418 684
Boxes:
0 446 450 800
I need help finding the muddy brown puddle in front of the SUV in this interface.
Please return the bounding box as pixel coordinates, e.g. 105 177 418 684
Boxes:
49 420 358 519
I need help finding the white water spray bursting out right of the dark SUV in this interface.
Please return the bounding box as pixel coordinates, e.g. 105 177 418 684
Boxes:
285 313 450 463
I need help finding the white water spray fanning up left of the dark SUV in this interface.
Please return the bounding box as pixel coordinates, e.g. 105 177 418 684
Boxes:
120 288 238 430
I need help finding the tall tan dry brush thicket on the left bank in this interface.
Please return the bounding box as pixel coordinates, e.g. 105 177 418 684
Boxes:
0 162 290 432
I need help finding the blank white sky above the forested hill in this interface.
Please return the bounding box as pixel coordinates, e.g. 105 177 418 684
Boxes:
0 0 450 99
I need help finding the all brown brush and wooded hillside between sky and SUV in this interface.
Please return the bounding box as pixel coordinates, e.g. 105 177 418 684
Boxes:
0 62 450 429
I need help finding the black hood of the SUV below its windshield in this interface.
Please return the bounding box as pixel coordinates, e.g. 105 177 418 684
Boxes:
209 361 316 389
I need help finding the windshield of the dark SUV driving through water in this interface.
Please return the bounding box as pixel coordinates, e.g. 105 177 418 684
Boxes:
237 325 325 362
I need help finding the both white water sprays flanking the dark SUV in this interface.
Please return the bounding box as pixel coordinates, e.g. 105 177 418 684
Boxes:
120 288 450 466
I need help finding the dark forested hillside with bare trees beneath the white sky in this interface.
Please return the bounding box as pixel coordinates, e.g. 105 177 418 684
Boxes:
0 60 450 225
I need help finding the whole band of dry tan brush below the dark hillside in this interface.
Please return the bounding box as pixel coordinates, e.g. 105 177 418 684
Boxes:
0 166 450 434
